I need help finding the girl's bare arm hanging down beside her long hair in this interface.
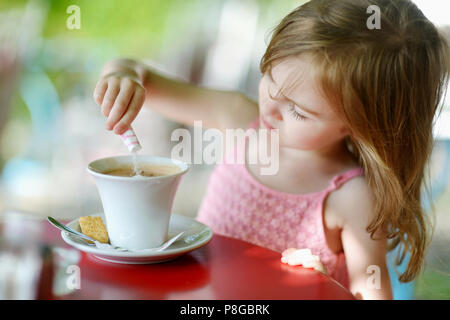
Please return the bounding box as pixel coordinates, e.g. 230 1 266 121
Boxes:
334 178 393 300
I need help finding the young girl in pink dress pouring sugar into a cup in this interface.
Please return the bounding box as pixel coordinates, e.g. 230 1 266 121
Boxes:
94 0 449 299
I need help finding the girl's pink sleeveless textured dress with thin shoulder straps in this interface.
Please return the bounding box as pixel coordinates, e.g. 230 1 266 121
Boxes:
197 121 364 289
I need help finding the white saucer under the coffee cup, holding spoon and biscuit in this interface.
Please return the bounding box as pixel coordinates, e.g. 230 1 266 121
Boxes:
61 213 212 264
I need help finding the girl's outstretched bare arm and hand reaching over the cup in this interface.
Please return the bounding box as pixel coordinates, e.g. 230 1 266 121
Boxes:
94 59 258 134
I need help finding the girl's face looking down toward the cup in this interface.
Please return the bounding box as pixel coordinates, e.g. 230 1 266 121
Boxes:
259 56 348 150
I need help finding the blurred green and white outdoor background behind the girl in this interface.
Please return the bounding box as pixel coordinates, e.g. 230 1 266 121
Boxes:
0 0 450 299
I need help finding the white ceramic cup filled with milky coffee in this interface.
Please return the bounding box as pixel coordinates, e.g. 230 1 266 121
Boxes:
87 156 190 250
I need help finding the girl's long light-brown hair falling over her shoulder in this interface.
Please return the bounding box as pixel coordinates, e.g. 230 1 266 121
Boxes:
260 0 449 282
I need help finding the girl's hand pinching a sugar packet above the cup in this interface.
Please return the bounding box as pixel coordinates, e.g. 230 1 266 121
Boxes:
94 72 145 134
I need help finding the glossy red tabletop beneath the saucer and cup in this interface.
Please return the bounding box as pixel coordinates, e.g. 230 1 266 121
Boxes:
43 221 354 300
